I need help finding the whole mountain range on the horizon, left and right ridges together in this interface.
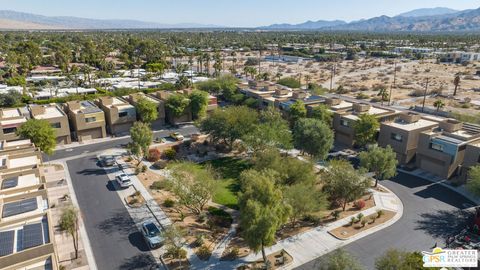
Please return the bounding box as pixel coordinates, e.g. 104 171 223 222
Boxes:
0 7 480 32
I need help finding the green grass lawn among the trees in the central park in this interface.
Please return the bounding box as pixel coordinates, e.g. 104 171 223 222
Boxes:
204 157 251 209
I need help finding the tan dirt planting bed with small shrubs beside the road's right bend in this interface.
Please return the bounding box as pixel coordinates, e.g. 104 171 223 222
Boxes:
328 210 396 240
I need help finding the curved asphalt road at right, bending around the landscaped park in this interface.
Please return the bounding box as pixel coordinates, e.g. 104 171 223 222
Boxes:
297 173 474 270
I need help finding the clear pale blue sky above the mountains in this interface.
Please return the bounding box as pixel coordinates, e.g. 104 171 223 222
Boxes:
0 0 480 27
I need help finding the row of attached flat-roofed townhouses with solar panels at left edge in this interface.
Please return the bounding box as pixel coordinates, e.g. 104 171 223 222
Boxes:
0 140 58 270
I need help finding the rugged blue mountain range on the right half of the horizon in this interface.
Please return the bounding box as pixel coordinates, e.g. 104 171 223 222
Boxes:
260 8 480 32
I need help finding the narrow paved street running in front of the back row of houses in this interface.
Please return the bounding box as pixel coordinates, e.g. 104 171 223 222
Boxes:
44 125 198 162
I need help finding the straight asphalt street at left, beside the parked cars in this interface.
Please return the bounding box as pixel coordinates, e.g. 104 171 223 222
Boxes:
67 156 156 269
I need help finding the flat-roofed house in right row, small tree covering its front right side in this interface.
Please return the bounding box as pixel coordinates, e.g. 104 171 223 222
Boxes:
330 103 399 147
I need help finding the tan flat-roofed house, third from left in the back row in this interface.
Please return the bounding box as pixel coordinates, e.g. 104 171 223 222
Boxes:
65 101 107 142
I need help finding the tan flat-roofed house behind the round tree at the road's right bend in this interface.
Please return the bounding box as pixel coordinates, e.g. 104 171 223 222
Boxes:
378 112 439 165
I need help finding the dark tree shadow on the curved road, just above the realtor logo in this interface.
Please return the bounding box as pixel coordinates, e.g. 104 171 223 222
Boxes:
415 210 473 239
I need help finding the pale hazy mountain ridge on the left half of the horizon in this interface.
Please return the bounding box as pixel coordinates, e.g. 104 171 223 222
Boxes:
0 10 219 29
